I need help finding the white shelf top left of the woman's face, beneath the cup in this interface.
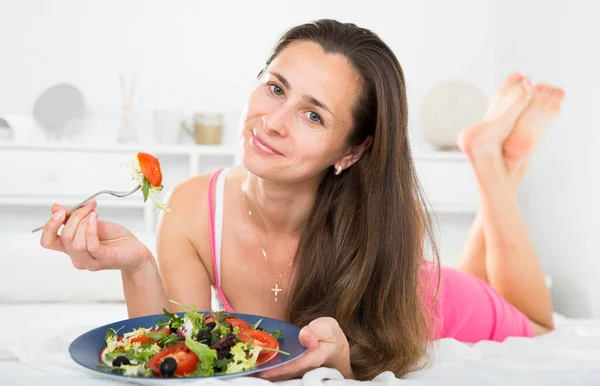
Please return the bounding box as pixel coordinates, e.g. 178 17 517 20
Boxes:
0 141 238 157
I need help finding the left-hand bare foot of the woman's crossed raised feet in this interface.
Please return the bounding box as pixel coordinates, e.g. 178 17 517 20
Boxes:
458 74 532 160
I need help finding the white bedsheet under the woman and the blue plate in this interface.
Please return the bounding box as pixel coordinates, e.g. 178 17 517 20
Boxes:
0 303 600 386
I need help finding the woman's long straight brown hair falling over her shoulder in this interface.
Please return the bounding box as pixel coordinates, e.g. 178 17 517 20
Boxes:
261 20 439 379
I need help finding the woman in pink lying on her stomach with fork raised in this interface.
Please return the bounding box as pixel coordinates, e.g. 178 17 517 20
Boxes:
41 20 562 379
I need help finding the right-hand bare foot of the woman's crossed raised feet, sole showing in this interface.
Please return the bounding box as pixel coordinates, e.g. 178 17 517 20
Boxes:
503 84 565 164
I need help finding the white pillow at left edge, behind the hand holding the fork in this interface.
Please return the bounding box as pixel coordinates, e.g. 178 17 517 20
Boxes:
0 233 156 303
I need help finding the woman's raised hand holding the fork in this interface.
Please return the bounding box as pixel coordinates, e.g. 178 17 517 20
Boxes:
40 201 152 272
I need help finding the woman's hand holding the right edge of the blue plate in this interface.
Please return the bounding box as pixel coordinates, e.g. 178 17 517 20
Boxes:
259 317 353 381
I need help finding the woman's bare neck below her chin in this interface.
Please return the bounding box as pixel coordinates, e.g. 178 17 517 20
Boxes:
243 173 320 236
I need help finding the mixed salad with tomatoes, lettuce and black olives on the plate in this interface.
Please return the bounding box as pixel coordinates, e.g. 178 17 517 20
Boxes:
98 307 289 378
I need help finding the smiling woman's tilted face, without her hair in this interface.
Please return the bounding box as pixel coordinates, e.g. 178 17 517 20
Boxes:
241 41 360 183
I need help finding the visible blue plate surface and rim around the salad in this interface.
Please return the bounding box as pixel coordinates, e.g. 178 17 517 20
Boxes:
69 312 306 381
